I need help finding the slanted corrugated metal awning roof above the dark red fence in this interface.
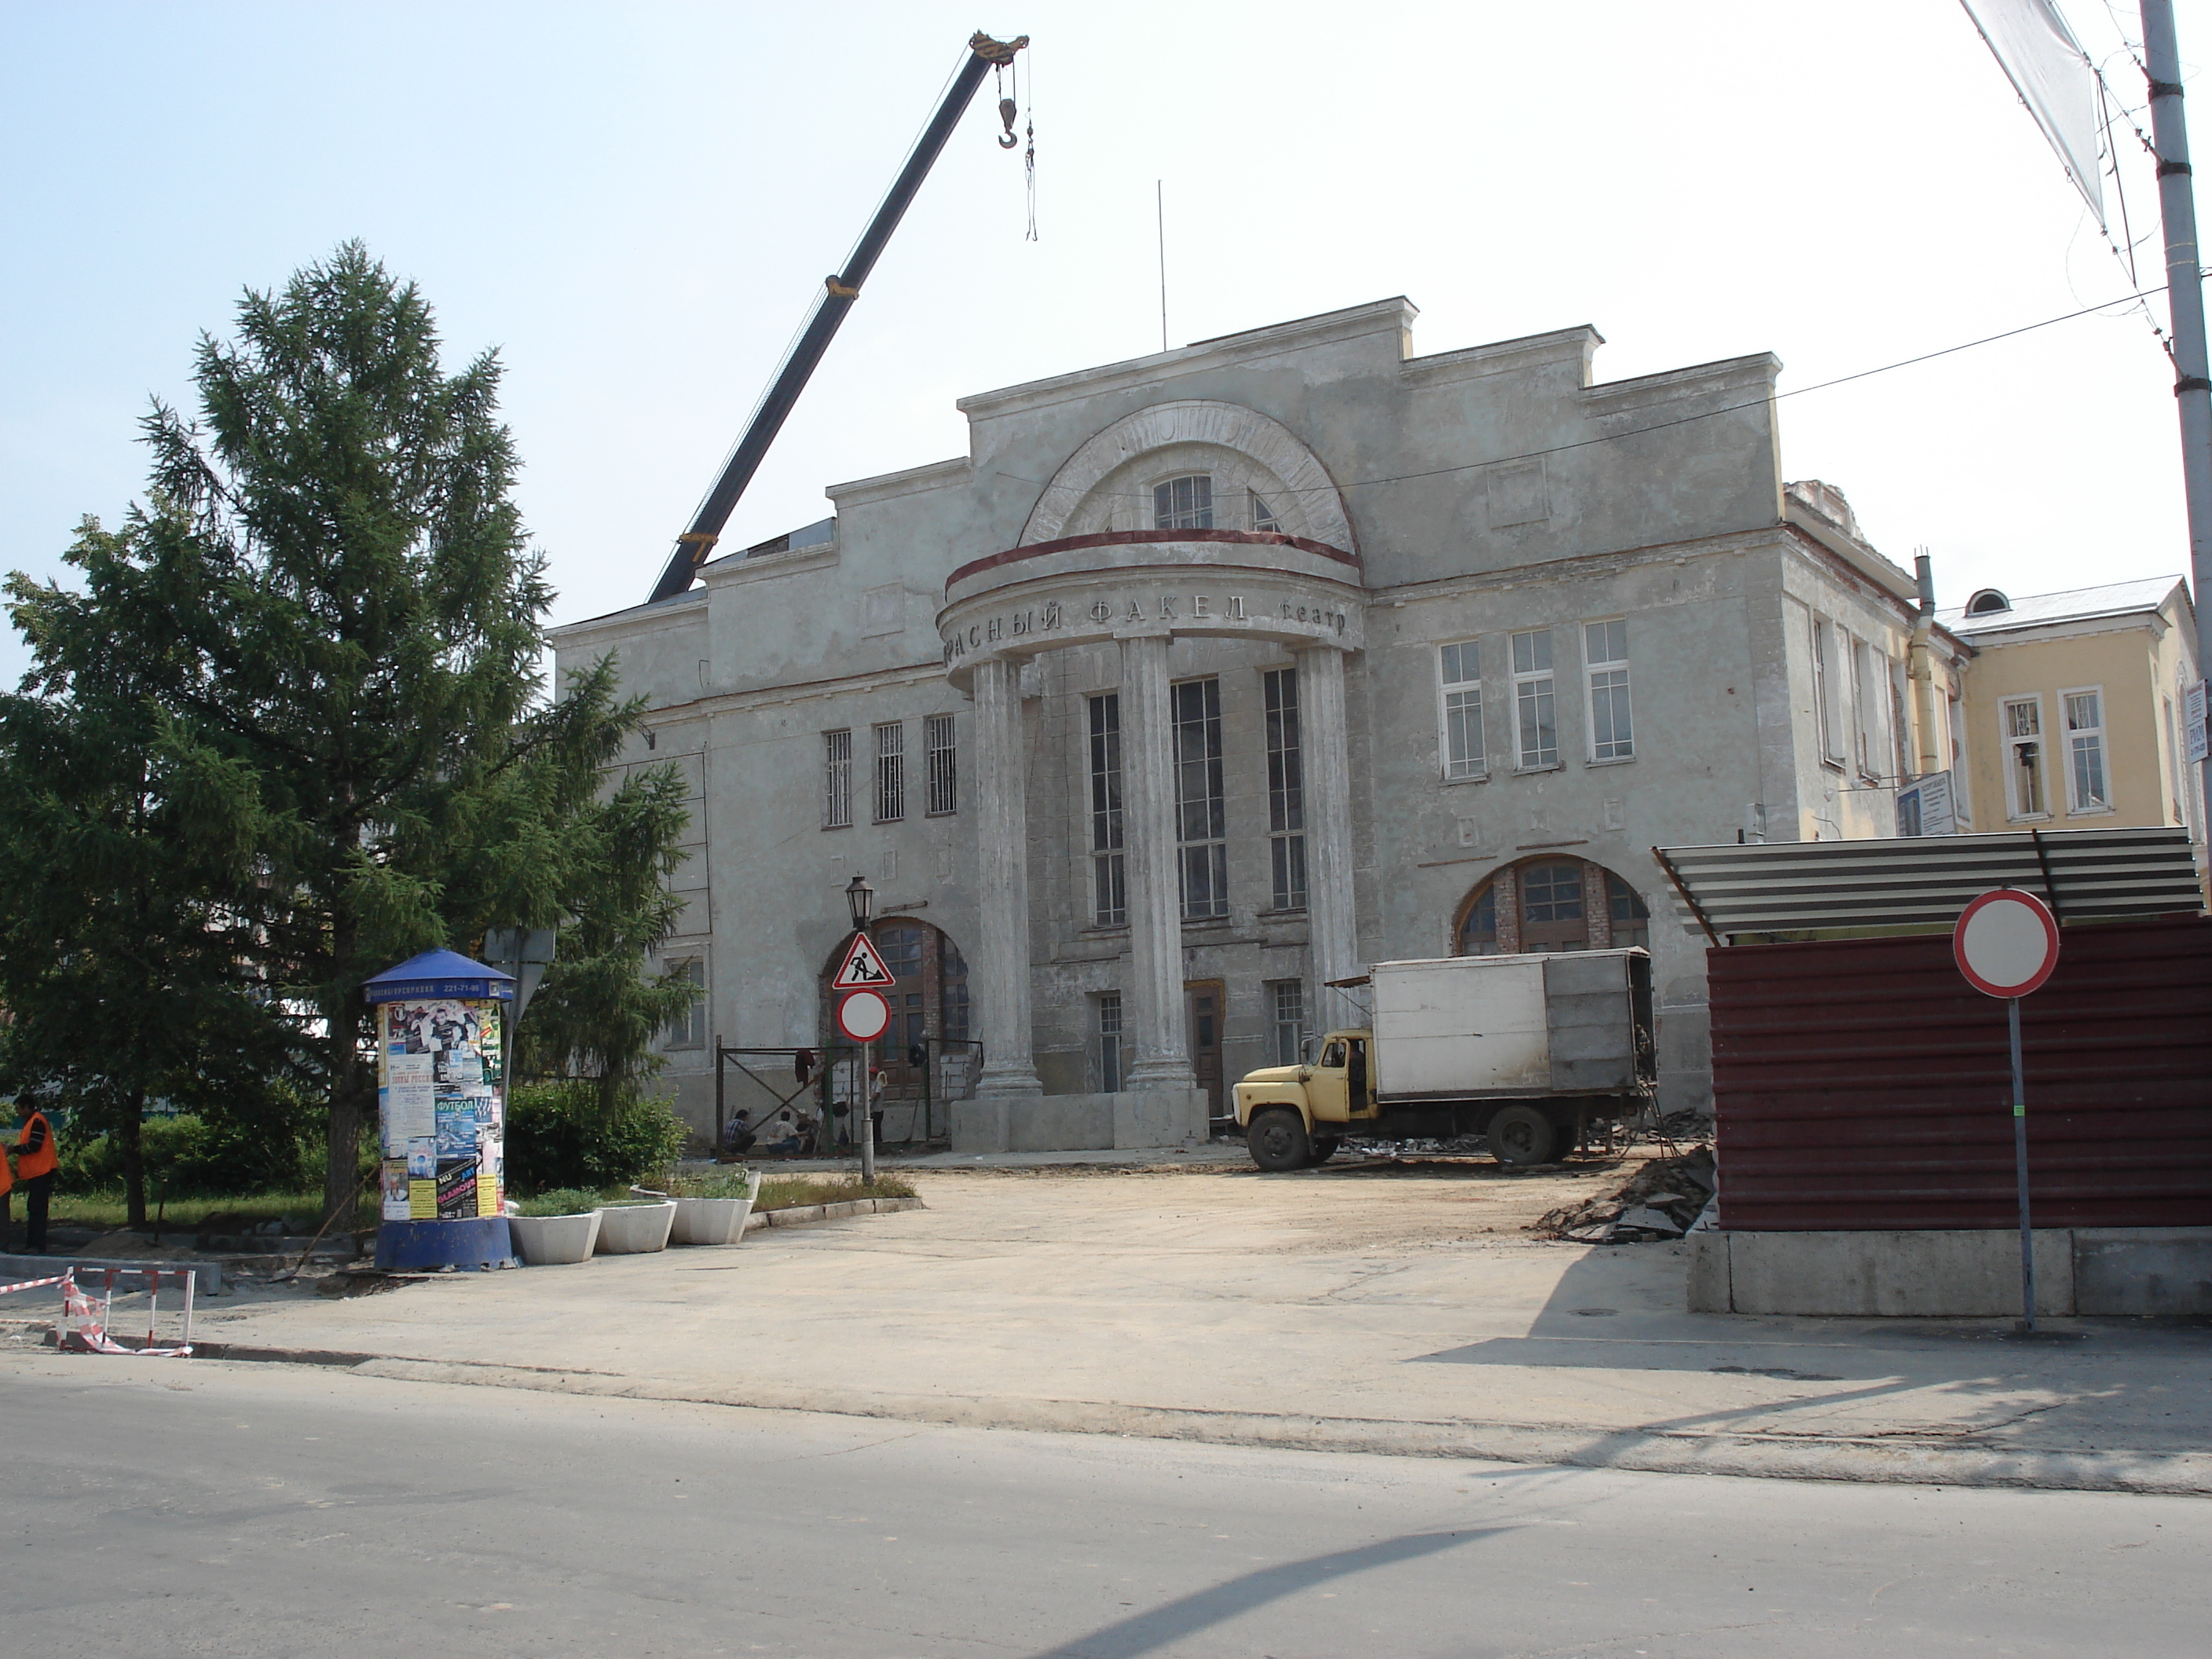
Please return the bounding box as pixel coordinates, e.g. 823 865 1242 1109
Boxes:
1653 827 2203 940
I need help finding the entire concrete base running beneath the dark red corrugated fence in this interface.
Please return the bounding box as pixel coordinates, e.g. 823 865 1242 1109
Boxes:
1688 1228 2212 1318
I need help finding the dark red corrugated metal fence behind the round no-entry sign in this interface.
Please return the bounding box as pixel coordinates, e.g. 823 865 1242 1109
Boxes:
1705 916 2212 1232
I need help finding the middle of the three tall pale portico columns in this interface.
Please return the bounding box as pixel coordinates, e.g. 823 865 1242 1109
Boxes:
1122 635 1199 1088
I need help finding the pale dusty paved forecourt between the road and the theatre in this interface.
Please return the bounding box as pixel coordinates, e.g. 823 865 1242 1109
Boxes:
42 1166 2212 1493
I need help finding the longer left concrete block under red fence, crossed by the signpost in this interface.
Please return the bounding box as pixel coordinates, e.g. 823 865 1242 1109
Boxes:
1727 1228 2075 1318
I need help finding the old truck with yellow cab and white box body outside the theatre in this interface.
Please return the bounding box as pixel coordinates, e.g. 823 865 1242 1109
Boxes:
1234 949 1657 1170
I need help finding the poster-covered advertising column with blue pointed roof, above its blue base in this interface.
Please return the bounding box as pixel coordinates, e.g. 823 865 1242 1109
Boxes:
367 951 513 1247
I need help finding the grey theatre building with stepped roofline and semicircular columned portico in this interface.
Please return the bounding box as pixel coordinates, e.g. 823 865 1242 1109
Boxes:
555 298 1966 1146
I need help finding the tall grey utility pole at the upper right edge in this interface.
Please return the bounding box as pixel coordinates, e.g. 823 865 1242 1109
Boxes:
2144 0 2212 834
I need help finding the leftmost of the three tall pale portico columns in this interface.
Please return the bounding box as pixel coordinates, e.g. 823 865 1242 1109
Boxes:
969 657 1042 1095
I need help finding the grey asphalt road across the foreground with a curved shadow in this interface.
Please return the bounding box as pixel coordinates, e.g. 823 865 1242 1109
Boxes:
0 1353 2212 1659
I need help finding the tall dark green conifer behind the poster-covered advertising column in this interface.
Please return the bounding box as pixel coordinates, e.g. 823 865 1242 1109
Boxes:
2 244 690 1238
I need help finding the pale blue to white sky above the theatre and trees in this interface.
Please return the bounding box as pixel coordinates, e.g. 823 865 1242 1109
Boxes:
0 0 2212 681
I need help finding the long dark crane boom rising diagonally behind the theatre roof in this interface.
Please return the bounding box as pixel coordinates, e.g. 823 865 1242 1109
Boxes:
646 33 1028 604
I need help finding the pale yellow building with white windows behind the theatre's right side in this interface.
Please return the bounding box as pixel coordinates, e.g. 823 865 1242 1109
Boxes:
1940 575 2203 840
